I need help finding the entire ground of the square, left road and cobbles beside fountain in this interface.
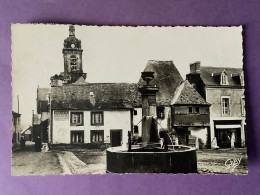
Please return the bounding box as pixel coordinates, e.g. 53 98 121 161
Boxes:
12 146 248 175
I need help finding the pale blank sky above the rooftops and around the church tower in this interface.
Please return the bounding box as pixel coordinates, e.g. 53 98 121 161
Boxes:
12 24 243 128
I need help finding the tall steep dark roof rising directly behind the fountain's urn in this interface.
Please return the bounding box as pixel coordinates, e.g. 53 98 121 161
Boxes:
139 60 183 105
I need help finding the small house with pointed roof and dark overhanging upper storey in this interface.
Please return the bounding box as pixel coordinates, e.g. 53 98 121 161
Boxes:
171 80 210 148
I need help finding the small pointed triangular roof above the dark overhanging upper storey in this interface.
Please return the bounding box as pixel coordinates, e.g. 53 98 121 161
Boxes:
171 80 210 105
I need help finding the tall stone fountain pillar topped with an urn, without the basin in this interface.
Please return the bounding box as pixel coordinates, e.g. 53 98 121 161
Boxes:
138 72 159 146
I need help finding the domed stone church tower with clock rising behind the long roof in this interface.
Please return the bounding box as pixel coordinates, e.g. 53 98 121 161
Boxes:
51 25 87 87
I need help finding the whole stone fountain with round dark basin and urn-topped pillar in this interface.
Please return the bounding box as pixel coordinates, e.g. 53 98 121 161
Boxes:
106 72 197 173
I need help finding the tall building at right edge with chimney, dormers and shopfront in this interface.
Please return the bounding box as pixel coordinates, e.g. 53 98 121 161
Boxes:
187 62 246 147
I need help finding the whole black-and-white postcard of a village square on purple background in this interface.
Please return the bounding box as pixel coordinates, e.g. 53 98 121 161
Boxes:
12 24 248 176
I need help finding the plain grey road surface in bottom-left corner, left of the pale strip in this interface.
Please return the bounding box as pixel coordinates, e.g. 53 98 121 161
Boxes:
12 142 63 176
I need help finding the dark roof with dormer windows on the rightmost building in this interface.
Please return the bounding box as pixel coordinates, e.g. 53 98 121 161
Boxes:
200 66 243 86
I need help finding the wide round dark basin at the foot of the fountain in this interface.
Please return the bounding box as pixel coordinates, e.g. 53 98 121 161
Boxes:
106 145 197 173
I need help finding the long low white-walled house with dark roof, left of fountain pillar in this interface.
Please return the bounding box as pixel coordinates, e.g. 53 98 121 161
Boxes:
50 83 141 146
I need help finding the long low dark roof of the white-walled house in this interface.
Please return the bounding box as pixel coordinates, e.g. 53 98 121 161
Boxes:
51 83 141 110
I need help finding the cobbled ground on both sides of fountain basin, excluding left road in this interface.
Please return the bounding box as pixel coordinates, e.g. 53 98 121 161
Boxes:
67 149 248 174
